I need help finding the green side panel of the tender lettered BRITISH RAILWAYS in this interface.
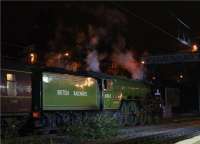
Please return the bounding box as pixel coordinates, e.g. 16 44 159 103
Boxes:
42 72 100 110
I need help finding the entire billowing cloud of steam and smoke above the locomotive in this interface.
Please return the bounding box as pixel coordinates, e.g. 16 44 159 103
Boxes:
46 4 144 79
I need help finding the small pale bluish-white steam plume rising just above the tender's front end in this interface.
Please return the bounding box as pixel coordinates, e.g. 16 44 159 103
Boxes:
86 50 100 72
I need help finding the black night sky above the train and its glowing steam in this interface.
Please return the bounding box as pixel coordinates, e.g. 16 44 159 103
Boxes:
1 2 200 82
